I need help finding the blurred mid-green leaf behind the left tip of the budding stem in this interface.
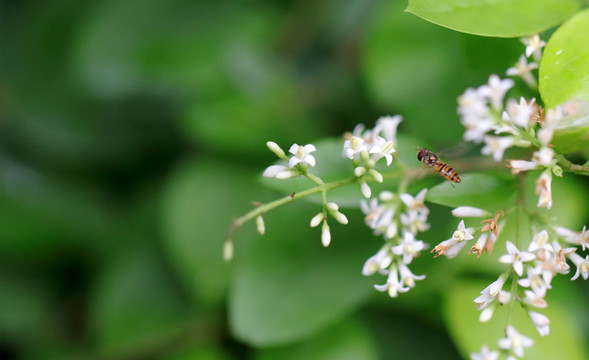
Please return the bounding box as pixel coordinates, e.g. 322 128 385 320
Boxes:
161 160 261 304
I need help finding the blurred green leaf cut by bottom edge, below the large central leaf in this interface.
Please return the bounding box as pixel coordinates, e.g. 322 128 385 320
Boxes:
255 320 379 360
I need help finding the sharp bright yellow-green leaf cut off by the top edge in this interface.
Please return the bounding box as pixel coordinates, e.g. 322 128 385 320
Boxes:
406 0 580 37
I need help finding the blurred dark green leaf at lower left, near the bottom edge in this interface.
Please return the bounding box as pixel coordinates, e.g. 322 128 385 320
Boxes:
89 244 188 354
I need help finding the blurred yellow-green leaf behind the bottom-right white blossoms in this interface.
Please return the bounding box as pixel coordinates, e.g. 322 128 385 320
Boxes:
444 279 589 360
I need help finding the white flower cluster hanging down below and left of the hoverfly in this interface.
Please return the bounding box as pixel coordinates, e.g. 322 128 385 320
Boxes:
361 189 429 297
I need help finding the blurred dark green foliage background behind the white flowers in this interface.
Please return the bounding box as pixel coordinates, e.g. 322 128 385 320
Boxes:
0 0 589 359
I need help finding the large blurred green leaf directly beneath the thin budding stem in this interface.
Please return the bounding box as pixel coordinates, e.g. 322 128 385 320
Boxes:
229 202 372 346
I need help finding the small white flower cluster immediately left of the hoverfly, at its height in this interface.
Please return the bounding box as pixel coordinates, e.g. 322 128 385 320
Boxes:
343 115 403 199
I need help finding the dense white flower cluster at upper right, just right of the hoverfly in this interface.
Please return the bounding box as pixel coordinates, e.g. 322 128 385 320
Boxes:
458 35 564 208
